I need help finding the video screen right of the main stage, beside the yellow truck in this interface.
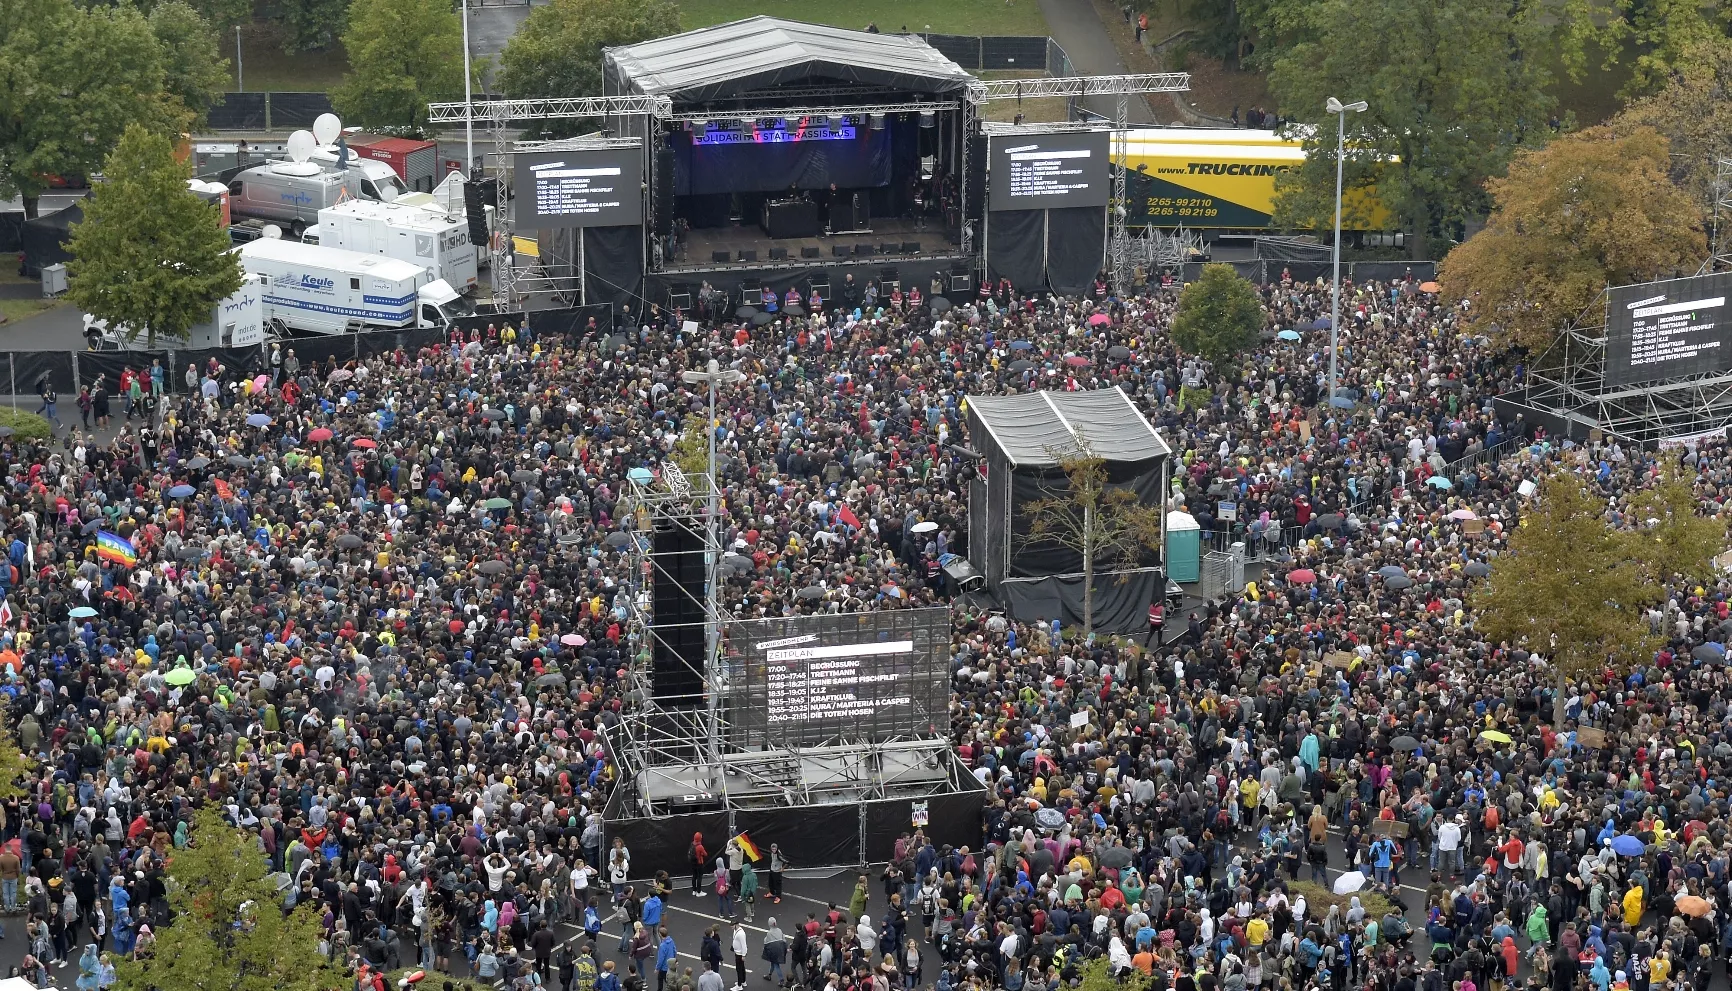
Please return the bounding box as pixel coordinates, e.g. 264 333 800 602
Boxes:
987 130 1112 210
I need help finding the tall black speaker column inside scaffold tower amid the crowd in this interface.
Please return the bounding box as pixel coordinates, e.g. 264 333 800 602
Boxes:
650 521 707 709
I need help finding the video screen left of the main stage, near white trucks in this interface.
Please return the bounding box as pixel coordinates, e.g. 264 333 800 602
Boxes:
513 147 643 230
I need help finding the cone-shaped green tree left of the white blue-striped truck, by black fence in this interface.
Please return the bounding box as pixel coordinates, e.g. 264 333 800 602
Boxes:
68 126 241 347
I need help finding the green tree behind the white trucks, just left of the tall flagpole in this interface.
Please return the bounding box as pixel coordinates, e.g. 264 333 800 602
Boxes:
331 0 462 126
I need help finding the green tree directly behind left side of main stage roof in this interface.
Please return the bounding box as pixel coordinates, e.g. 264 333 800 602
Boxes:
499 0 679 137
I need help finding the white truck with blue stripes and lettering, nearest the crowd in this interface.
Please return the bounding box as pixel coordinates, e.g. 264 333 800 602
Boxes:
237 237 471 336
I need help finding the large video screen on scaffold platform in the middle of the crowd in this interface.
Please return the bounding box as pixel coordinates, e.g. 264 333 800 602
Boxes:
724 608 951 747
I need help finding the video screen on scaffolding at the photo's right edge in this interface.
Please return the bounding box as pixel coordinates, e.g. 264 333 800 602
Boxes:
1606 272 1732 385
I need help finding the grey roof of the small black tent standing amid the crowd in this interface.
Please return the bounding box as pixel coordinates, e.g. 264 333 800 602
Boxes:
968 386 1173 468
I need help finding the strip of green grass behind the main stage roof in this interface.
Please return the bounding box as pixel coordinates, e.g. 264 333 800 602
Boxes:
672 0 1048 36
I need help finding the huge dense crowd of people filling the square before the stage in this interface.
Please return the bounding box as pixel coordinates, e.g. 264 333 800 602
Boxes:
0 266 1732 991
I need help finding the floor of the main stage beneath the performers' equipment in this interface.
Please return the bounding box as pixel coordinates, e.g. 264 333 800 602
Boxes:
663 217 958 274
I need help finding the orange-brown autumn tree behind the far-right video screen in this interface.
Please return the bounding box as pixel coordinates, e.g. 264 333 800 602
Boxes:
1438 126 1706 350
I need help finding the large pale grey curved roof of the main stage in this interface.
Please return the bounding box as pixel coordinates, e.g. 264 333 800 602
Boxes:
606 16 973 104
